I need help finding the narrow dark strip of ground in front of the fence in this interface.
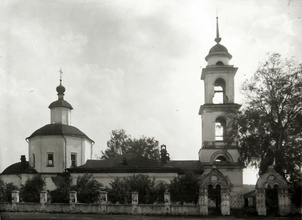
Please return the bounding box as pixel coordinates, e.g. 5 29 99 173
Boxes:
0 212 301 220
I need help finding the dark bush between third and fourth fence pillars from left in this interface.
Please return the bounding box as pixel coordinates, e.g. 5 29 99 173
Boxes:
71 174 103 203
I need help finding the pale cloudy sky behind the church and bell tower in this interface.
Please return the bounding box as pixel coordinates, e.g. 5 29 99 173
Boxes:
0 0 302 184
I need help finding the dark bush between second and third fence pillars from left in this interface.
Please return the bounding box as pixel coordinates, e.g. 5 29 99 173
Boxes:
51 173 71 203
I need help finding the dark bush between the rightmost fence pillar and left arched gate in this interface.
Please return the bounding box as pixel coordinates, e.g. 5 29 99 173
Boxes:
170 172 199 203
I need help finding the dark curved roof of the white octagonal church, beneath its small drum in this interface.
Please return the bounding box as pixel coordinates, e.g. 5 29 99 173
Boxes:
26 124 94 142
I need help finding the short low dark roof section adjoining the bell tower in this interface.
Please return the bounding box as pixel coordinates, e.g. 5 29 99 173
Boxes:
167 160 204 174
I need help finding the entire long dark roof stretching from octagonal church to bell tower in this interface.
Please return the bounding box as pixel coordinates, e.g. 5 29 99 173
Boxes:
67 153 203 174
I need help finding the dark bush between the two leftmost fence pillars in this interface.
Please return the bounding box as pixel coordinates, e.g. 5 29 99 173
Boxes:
20 174 46 202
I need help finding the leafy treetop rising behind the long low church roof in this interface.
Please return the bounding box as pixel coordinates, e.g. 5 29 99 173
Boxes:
101 129 159 160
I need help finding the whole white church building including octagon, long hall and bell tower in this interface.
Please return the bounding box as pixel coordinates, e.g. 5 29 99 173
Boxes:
0 19 244 208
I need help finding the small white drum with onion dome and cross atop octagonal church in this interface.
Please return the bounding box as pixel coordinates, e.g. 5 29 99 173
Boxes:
49 70 73 125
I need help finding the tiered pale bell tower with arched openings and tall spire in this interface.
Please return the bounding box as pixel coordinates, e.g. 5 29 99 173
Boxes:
199 17 240 164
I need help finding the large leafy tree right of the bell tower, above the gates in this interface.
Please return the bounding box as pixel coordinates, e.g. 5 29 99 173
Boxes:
228 54 302 184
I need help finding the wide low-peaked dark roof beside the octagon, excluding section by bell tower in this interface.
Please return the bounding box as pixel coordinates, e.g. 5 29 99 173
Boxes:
67 153 179 173
